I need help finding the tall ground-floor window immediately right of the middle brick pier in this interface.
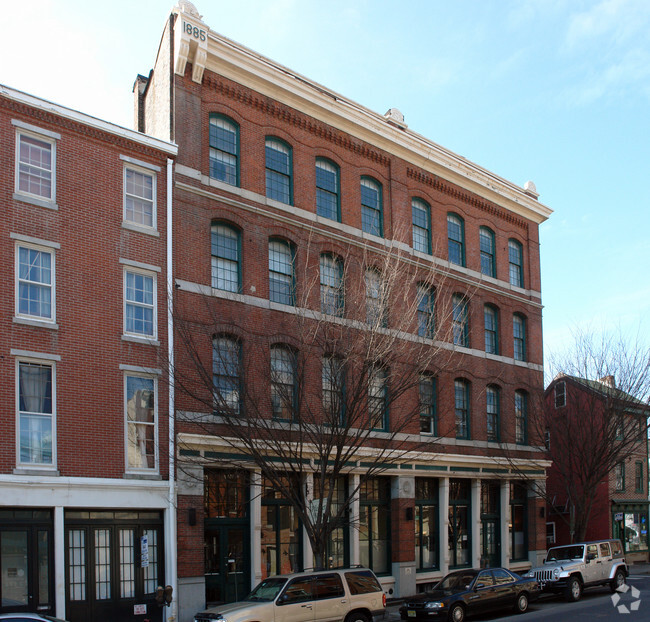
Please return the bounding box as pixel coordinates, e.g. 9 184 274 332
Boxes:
415 477 440 571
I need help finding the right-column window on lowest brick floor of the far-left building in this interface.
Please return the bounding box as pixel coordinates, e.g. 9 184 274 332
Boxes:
124 372 158 473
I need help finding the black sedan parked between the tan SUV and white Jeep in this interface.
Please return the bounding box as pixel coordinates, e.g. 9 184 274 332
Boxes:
399 568 540 622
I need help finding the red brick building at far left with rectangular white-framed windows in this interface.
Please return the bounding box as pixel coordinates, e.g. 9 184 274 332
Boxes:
0 86 176 621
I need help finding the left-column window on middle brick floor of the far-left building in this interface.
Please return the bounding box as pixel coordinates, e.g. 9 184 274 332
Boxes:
16 241 56 322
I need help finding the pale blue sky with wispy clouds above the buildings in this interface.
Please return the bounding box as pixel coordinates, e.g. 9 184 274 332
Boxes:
0 0 650 364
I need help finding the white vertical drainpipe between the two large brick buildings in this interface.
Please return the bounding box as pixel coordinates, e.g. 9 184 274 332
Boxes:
165 158 178 621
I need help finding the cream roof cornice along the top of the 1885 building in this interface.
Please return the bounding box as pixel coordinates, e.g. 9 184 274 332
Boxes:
174 8 552 224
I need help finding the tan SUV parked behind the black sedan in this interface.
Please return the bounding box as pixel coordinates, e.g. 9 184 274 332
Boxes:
194 568 386 622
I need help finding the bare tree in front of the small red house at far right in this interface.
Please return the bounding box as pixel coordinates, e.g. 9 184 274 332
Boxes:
531 331 650 541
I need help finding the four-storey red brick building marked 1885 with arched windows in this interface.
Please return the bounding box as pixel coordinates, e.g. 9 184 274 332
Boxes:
135 2 551 620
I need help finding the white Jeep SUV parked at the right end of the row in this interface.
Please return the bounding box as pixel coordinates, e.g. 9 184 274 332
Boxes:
525 540 628 602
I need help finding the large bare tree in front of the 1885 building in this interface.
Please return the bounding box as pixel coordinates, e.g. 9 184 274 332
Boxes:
172 236 460 567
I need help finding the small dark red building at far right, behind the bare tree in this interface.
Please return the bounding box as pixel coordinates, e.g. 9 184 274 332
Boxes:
544 374 650 561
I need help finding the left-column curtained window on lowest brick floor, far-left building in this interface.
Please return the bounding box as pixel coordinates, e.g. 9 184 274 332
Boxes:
16 358 56 468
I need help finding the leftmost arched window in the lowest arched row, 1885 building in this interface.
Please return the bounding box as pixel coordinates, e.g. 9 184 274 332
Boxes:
212 335 241 415
